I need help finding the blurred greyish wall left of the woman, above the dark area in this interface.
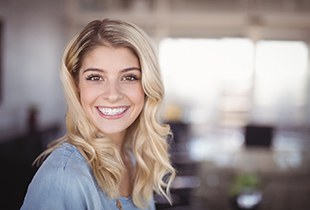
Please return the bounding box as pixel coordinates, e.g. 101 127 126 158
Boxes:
0 0 67 141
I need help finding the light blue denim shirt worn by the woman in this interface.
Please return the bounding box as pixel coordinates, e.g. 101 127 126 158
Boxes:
21 143 155 210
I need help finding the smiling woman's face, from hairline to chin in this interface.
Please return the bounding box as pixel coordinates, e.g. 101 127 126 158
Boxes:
78 46 144 139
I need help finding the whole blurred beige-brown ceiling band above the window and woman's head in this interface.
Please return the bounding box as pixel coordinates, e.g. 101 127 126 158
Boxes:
67 0 310 41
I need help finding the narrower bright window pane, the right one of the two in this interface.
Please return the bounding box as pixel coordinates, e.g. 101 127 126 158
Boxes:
254 41 308 124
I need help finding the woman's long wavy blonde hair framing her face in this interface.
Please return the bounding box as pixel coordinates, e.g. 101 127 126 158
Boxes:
39 19 175 208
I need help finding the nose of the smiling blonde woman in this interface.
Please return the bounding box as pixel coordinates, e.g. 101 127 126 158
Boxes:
103 81 123 103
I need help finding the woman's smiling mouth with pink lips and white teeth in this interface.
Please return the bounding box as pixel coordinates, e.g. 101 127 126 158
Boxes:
96 106 129 119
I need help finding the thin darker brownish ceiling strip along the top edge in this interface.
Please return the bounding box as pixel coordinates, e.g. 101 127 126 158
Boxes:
79 0 310 13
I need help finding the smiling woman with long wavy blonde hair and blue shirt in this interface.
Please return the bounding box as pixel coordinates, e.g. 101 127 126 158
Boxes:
21 19 175 210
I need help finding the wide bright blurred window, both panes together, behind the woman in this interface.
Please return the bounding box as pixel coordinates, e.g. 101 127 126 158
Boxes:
159 38 308 126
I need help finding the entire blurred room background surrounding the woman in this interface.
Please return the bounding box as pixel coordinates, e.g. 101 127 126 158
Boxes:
0 0 310 210
